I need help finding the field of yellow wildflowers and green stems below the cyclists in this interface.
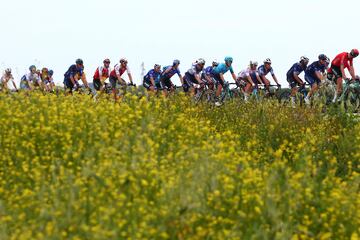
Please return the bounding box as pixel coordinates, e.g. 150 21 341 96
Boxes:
0 93 360 240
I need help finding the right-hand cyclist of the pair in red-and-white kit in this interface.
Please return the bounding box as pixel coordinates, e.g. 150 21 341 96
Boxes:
109 58 133 98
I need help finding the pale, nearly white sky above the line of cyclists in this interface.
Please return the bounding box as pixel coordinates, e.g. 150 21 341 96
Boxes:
0 0 360 85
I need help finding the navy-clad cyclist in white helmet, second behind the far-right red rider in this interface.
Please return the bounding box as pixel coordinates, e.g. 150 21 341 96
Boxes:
286 56 309 106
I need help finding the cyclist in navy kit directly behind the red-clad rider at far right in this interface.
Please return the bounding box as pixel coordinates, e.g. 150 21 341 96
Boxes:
305 54 328 105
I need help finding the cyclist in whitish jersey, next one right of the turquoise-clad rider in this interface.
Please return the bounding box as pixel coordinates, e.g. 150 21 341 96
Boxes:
236 61 262 102
